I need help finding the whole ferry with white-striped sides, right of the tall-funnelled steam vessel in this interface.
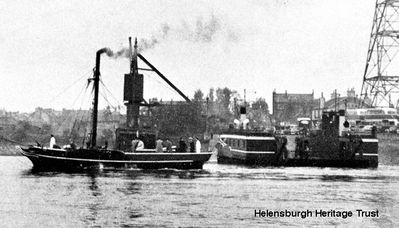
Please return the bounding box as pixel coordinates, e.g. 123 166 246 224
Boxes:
216 109 378 168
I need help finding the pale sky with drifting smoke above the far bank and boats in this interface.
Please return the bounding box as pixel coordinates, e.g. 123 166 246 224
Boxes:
0 0 375 112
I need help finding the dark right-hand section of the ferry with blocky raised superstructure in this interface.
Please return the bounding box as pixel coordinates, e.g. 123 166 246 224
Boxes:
283 110 378 168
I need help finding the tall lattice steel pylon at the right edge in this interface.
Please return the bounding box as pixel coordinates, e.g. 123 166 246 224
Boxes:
361 0 399 107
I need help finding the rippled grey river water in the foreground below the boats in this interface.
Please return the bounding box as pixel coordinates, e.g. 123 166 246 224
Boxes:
0 156 399 227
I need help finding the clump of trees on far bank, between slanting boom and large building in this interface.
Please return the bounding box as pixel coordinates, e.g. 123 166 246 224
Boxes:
151 87 271 139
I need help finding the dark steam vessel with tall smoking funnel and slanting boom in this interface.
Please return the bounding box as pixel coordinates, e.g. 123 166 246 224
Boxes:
21 38 212 171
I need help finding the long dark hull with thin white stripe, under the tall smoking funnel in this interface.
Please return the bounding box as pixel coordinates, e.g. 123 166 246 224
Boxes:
21 146 212 171
